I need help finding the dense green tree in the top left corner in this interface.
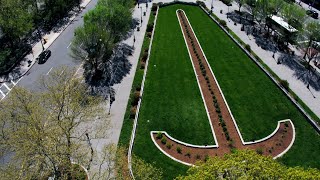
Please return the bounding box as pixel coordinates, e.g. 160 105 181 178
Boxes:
0 0 33 46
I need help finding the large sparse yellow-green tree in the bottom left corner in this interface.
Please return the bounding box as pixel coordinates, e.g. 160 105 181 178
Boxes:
0 67 109 179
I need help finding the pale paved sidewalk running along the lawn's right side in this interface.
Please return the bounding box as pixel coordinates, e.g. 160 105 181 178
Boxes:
200 0 320 117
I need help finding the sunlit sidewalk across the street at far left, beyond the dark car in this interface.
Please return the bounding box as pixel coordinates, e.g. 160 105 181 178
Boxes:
0 0 91 83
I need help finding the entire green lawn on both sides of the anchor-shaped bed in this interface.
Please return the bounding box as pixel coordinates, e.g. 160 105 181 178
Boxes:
120 5 320 179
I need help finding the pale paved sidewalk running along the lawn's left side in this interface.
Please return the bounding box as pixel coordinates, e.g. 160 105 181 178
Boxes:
87 3 152 177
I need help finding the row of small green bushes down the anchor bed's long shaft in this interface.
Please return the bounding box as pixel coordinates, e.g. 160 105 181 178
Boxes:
178 10 233 144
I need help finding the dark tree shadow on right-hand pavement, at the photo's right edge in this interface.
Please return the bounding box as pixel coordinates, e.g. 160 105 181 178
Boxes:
278 53 320 91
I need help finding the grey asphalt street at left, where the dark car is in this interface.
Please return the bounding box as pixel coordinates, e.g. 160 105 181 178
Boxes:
18 0 98 91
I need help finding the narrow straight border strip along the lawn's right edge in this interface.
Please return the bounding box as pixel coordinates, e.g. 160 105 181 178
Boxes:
199 5 320 134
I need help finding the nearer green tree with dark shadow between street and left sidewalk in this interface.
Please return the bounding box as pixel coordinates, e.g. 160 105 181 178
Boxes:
71 23 115 90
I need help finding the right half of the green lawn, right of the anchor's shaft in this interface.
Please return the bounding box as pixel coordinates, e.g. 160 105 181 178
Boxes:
183 6 320 168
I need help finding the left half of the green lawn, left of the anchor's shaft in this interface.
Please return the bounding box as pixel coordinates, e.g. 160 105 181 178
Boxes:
119 6 214 179
